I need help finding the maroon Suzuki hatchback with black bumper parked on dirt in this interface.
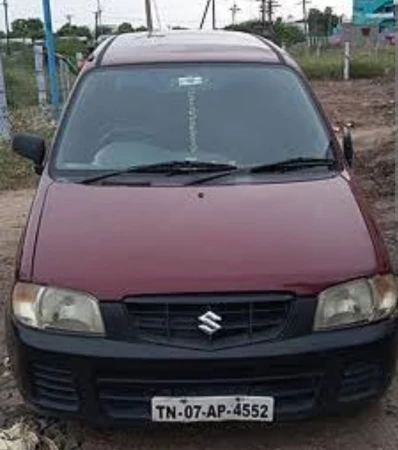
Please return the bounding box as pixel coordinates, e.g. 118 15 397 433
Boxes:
8 31 397 424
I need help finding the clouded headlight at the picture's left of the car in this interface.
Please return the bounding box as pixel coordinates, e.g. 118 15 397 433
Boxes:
12 283 105 335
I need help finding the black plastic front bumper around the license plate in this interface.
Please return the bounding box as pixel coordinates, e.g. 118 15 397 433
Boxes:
8 320 397 425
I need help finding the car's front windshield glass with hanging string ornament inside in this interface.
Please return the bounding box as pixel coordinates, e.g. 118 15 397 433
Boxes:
52 64 330 176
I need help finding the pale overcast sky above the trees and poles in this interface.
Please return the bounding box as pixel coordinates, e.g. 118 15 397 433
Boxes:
0 0 352 29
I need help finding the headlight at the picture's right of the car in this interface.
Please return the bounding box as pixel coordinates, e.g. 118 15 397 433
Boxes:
314 275 397 330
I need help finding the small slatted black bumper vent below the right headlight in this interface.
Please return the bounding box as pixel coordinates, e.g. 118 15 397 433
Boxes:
339 361 384 402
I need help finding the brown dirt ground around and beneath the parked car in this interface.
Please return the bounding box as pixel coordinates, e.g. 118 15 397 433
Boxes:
0 79 398 450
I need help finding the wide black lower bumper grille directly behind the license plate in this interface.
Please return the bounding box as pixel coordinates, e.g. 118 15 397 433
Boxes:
97 371 322 420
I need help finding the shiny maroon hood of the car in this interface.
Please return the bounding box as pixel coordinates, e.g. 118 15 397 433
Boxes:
32 176 377 300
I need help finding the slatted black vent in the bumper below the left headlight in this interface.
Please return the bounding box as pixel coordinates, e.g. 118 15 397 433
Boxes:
30 362 79 412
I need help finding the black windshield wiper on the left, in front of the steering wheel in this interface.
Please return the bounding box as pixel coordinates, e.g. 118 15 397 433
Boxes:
80 160 238 184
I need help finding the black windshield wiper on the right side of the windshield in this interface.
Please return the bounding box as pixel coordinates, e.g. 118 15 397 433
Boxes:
185 157 337 186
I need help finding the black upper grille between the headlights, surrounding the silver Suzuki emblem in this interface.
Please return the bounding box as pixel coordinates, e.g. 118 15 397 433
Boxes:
125 295 291 348
